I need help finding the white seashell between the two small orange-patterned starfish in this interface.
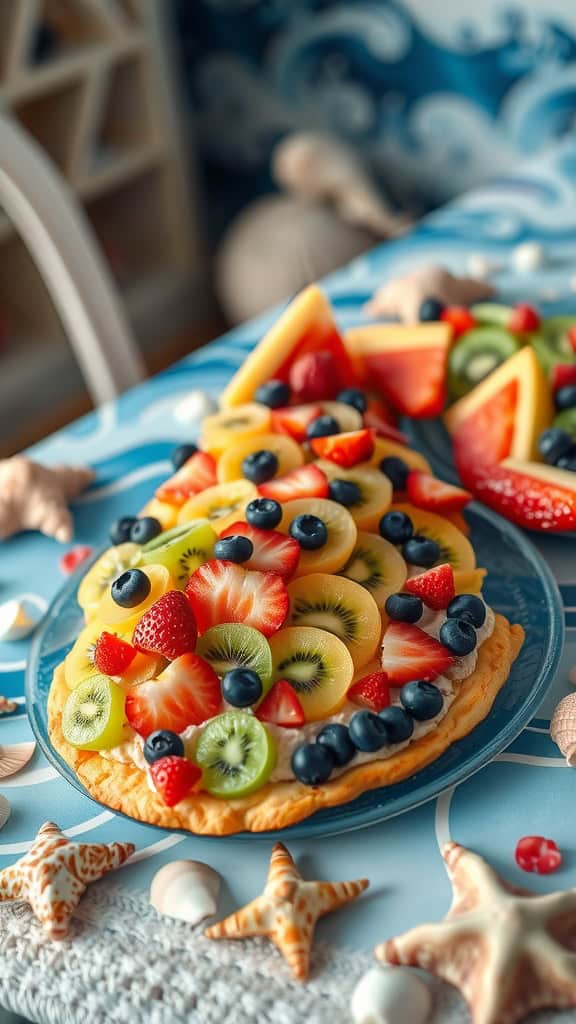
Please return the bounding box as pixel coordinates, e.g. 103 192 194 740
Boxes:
150 860 220 925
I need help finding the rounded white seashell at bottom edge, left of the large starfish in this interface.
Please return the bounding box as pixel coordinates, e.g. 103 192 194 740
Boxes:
351 967 431 1024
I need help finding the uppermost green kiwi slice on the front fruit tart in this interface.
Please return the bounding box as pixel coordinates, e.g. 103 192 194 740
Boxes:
140 519 216 590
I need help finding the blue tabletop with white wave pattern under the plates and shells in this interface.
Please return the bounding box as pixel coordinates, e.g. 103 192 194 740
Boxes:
0 140 576 949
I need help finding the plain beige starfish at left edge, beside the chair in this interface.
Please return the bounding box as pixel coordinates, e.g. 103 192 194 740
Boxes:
0 456 94 542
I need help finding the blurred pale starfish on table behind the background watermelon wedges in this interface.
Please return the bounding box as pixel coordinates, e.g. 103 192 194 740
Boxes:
365 263 494 324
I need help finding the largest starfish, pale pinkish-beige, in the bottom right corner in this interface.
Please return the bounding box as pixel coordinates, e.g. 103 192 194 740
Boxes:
375 843 576 1024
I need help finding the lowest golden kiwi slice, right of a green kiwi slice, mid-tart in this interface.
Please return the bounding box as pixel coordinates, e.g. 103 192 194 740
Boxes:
270 626 354 722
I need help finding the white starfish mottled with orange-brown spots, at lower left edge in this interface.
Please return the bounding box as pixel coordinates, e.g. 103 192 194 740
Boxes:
0 821 134 939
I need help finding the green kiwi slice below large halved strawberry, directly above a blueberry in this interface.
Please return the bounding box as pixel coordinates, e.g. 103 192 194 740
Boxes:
196 623 272 693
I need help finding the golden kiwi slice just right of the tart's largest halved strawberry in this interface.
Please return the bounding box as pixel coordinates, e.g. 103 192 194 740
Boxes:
288 572 381 669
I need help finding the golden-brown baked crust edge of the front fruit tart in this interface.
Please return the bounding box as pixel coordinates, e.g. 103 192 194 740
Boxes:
48 615 524 836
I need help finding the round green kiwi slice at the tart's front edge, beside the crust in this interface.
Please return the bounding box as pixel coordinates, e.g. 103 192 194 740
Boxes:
195 711 276 799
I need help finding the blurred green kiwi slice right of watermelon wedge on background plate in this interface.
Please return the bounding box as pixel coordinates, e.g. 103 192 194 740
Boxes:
448 325 521 399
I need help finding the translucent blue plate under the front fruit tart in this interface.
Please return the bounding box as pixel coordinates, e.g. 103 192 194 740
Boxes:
26 503 564 840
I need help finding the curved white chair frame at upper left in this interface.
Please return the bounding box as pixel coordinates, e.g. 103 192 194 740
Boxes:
0 114 146 404
